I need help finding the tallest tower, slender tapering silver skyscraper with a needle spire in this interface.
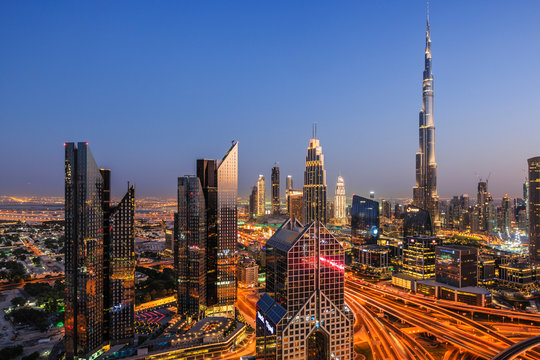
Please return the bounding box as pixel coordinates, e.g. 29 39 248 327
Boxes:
413 7 440 229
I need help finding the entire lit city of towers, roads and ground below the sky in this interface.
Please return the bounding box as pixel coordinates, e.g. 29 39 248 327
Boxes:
0 4 540 360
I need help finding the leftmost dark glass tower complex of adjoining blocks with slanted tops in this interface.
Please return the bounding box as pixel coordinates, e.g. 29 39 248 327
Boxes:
64 142 135 359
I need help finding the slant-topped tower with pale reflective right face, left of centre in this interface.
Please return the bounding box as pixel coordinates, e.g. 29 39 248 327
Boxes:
197 142 238 317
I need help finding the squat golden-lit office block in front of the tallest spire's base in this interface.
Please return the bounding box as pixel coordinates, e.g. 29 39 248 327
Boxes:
403 235 442 280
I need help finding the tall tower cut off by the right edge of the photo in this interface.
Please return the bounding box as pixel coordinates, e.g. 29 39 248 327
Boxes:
527 156 540 264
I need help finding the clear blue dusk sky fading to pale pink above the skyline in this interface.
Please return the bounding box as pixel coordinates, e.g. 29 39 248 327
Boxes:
0 0 540 199
